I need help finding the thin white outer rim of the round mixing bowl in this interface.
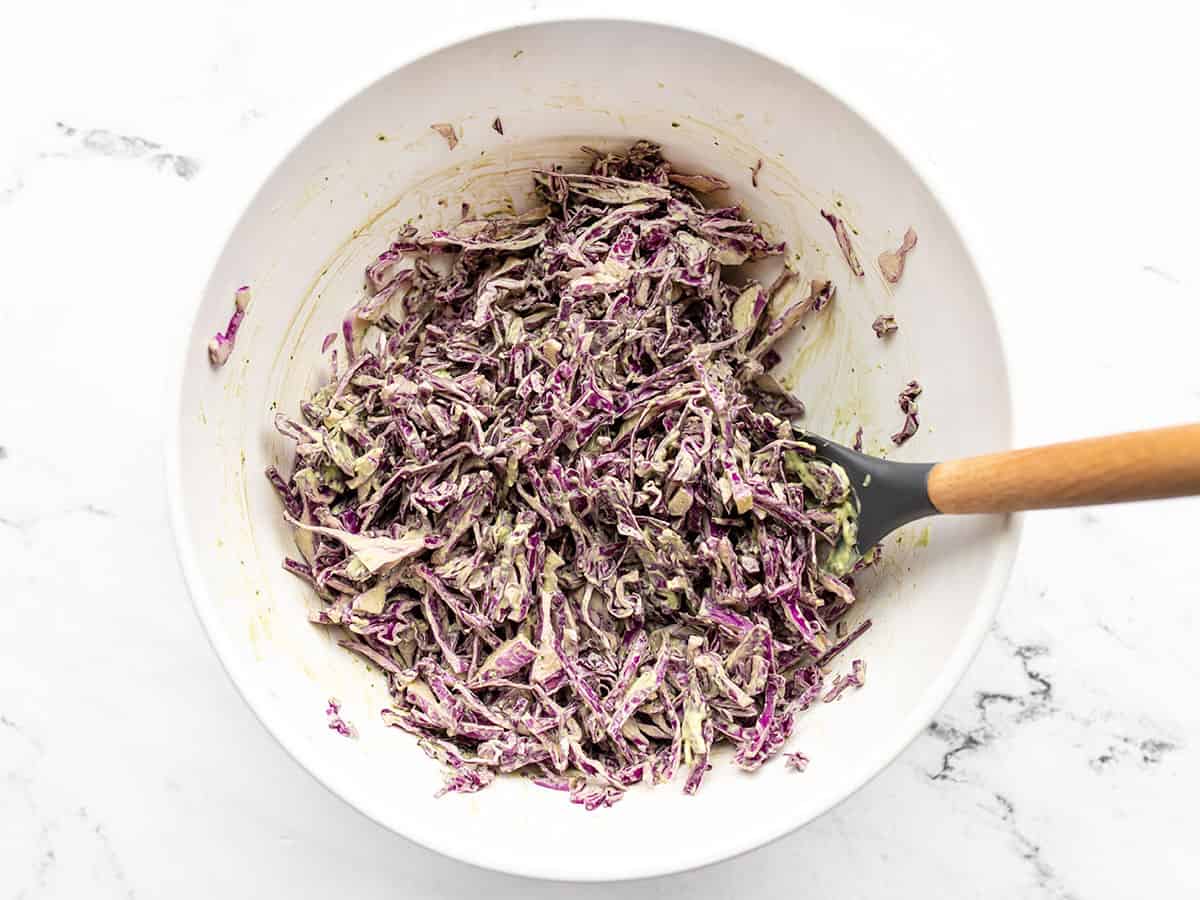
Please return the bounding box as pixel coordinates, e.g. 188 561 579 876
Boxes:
163 14 1024 882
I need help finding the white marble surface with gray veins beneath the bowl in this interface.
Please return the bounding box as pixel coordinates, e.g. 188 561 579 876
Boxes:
0 0 1200 900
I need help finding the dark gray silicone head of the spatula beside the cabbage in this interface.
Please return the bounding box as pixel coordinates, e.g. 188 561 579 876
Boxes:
804 432 937 556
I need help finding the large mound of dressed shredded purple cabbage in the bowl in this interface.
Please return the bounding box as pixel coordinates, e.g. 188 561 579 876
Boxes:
268 142 874 809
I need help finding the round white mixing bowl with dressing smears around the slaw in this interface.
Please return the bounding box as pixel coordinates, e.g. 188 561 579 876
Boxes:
167 22 1016 880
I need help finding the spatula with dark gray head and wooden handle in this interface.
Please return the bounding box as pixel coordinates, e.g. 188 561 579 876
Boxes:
804 425 1200 556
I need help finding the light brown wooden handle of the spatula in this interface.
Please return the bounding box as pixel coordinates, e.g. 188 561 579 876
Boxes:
928 425 1200 512
